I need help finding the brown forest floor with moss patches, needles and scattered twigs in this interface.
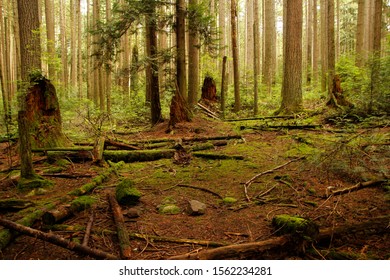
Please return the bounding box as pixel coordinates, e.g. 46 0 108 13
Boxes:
0 110 390 260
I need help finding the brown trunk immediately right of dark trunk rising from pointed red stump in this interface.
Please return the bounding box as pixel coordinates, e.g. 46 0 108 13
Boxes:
188 0 200 109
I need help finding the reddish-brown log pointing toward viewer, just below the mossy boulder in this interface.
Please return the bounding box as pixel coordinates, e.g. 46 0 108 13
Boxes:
108 193 132 259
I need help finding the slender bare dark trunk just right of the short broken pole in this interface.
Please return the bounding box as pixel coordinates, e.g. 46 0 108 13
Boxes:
231 0 241 113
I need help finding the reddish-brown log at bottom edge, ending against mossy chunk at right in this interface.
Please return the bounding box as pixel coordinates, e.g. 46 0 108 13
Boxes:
169 236 292 260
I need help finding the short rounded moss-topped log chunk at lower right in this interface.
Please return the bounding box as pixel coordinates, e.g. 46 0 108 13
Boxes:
272 215 319 241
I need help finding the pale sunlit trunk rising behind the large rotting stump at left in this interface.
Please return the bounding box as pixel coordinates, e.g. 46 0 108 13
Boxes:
45 0 56 79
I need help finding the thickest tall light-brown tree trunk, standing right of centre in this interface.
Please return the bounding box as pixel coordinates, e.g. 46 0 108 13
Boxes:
278 0 303 114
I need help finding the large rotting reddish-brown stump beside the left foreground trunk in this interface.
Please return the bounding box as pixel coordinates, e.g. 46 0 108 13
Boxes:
25 74 70 148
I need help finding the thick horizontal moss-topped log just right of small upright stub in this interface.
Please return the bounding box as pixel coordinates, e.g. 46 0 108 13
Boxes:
103 149 175 163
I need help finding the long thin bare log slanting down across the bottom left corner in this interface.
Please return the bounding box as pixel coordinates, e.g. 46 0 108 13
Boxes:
0 217 118 260
